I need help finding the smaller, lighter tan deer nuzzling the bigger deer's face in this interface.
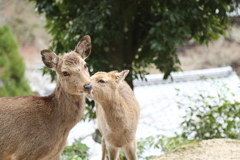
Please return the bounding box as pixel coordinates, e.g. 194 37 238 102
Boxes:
87 70 140 160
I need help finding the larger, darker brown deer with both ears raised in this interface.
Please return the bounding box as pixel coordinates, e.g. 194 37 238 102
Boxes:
0 35 92 160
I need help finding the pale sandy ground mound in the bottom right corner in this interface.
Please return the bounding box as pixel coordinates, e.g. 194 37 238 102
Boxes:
152 139 240 160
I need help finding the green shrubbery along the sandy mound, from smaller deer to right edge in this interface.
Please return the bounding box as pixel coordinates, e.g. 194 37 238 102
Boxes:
138 81 240 160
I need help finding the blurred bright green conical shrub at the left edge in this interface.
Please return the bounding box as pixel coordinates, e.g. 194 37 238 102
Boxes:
0 25 32 97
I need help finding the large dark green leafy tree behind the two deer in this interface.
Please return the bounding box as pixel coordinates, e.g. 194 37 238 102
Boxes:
29 0 238 86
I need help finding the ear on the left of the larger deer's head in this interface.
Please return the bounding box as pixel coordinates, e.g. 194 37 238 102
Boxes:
41 49 58 69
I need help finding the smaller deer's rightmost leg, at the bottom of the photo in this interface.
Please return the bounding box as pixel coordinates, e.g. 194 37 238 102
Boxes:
123 140 137 160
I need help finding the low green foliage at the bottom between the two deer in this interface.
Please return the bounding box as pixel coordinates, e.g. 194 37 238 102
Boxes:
61 138 89 160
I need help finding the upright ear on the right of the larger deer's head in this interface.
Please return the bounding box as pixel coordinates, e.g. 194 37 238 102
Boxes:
74 35 92 59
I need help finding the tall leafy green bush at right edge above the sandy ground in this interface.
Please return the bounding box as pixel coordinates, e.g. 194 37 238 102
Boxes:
178 81 240 140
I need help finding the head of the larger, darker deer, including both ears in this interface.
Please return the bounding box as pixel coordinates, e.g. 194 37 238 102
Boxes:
41 35 92 95
